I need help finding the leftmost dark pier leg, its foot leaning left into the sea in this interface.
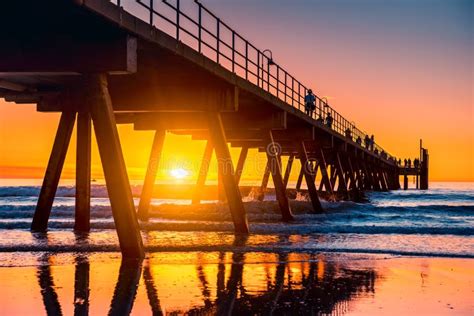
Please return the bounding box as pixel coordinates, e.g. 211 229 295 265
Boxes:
31 112 76 231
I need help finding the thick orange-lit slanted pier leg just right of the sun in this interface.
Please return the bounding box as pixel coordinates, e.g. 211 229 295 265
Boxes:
209 112 249 233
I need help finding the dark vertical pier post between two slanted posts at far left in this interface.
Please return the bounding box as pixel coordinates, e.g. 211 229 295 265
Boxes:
74 111 92 232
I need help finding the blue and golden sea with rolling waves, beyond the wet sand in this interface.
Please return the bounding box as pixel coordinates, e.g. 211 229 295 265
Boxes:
0 180 474 258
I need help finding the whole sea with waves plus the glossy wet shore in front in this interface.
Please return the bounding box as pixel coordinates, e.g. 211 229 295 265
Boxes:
0 180 474 315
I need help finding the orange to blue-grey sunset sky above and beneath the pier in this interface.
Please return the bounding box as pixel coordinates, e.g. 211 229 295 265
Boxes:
0 0 474 181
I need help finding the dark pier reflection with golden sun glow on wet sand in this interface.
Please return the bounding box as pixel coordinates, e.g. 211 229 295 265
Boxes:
31 240 376 315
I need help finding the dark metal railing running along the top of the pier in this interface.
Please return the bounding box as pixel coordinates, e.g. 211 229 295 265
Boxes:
112 0 395 160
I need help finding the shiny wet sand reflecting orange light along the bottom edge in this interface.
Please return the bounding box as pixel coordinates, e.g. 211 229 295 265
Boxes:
0 251 474 315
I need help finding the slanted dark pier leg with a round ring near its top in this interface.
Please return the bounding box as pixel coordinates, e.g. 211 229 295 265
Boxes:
266 131 294 221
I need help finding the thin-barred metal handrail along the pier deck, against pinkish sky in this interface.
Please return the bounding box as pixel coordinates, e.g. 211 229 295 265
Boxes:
112 0 396 161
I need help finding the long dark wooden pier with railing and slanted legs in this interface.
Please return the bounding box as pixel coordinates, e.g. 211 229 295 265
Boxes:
0 0 428 257
